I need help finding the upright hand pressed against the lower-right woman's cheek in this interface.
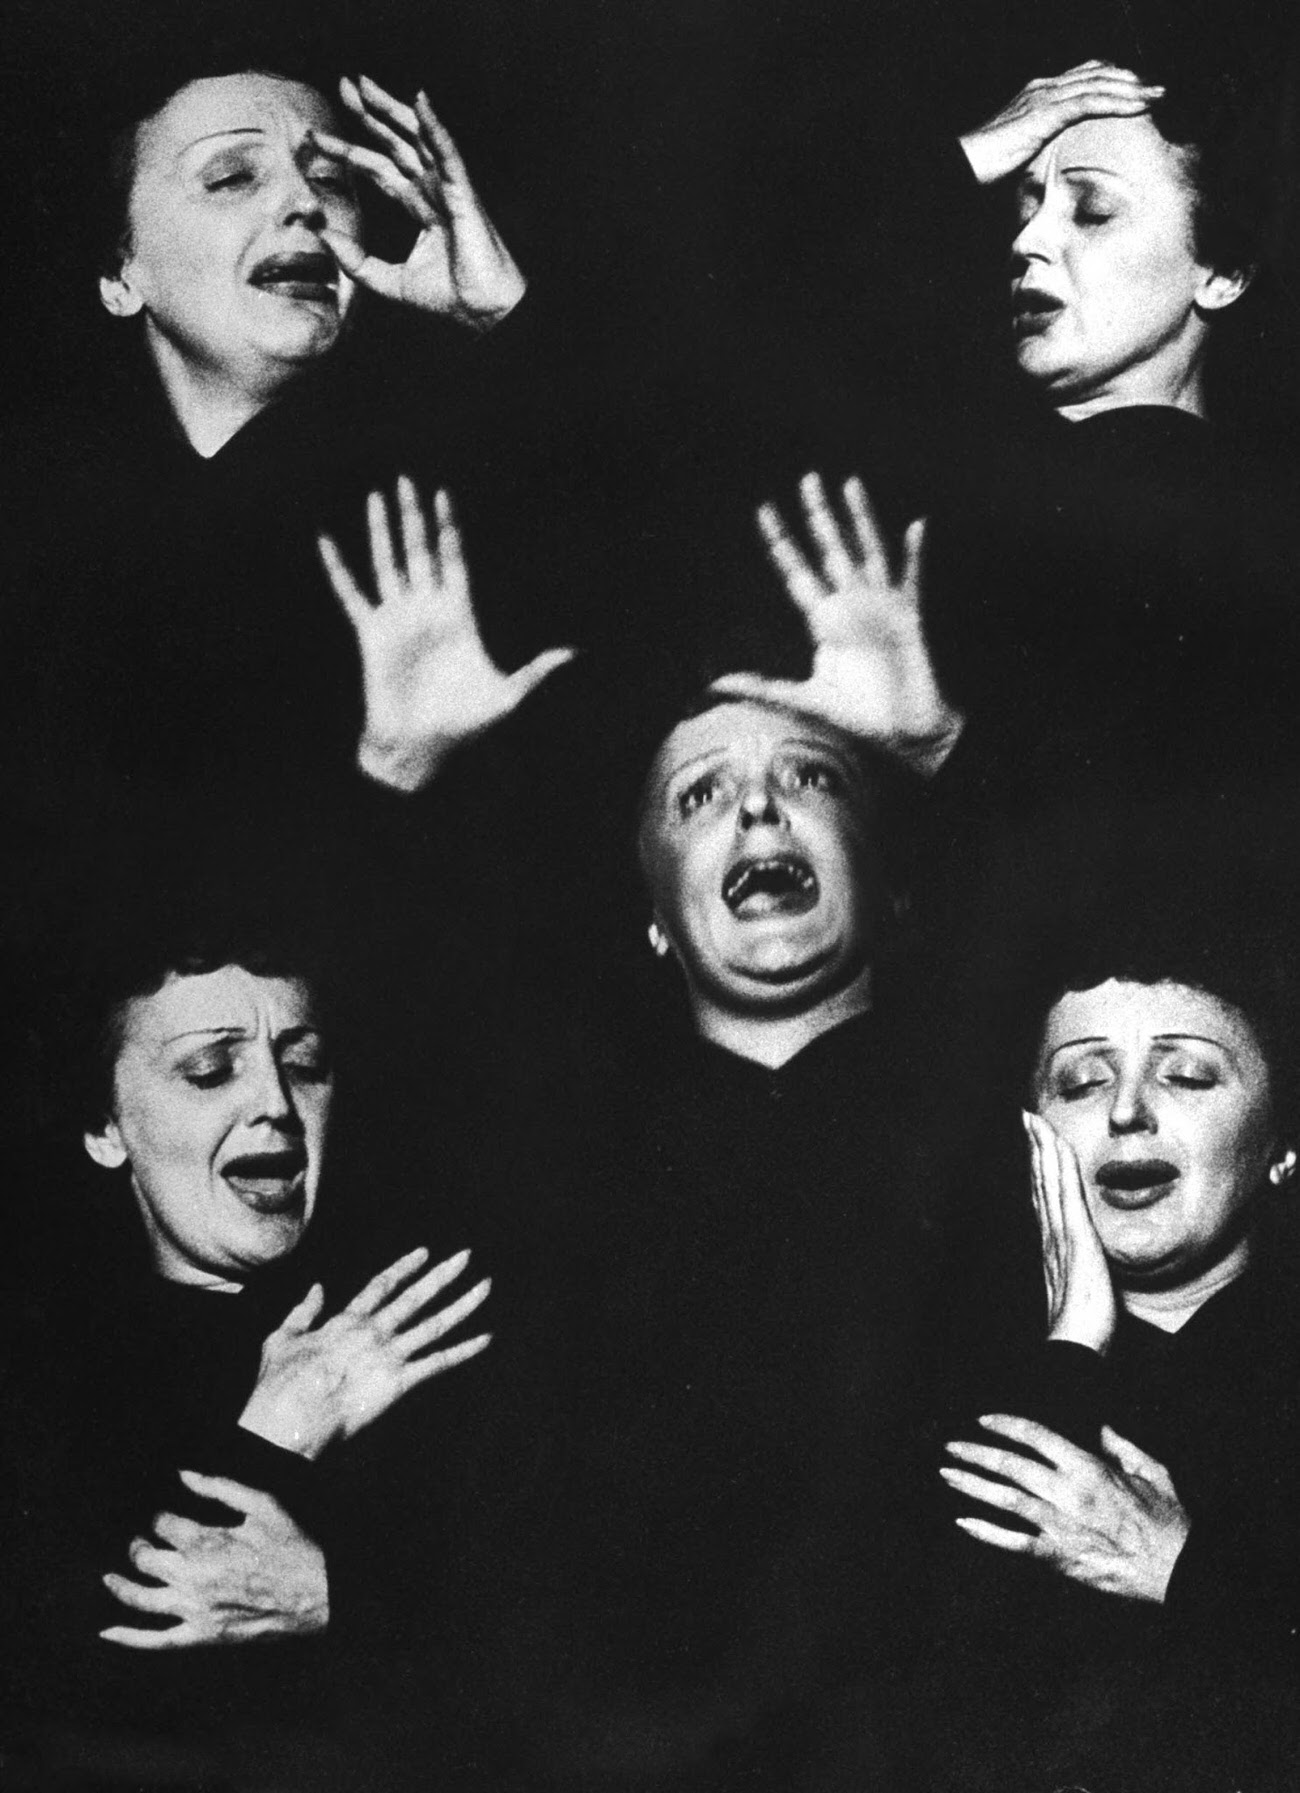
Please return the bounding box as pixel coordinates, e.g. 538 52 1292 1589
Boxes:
1022 1113 1115 1354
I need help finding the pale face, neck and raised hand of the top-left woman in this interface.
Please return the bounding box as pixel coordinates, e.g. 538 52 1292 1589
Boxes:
100 70 524 457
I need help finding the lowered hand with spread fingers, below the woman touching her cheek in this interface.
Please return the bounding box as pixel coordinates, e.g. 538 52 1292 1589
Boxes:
940 1413 1191 1603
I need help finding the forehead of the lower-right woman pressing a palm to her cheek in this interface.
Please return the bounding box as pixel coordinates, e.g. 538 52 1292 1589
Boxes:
1040 979 1264 1065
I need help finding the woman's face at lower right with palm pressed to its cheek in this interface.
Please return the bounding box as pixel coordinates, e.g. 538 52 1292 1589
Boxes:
1035 981 1277 1287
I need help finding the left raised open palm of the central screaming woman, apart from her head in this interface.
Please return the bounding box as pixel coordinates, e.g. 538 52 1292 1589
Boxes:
317 477 574 791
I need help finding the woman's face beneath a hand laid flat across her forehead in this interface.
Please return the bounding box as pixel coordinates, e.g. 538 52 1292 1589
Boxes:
1011 115 1244 403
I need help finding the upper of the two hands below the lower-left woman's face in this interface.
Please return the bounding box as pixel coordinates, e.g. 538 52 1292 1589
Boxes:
238 1246 491 1458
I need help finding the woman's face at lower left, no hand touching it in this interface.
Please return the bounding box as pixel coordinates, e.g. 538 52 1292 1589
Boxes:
86 965 332 1284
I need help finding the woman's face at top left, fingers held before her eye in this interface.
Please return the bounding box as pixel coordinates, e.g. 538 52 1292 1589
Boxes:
100 74 360 391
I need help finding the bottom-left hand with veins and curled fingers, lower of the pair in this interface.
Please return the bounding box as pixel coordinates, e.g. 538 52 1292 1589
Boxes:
99 1468 330 1650
